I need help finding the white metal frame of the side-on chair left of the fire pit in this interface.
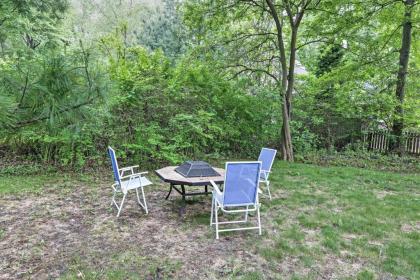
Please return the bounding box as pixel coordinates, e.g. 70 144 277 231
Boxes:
109 147 151 217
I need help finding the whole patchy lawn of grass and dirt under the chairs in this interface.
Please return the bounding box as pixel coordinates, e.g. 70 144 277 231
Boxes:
0 161 420 279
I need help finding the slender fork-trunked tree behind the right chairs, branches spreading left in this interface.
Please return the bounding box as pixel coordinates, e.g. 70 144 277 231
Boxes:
186 0 320 161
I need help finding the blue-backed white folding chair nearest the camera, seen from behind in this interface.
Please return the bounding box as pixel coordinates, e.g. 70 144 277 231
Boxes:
210 161 261 239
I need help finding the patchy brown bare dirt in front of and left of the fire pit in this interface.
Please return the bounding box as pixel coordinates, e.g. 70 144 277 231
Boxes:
0 178 266 279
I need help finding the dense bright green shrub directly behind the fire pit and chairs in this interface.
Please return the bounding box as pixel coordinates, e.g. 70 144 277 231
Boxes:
104 40 281 167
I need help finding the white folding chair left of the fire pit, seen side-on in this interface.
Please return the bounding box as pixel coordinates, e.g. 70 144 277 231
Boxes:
108 147 152 217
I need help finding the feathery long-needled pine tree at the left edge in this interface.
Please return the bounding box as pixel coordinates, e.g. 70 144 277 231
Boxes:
0 0 105 128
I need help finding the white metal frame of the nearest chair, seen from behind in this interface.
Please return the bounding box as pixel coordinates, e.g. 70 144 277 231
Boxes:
210 161 261 239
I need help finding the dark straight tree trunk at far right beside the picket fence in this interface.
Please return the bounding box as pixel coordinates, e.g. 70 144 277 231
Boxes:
392 0 414 153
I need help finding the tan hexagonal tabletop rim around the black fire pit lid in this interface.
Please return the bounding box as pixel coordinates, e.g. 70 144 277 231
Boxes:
155 166 225 186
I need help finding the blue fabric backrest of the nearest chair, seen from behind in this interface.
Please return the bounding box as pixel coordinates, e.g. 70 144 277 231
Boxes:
223 161 261 206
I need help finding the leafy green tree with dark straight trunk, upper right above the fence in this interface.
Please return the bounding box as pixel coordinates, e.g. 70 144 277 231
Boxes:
303 0 420 142
